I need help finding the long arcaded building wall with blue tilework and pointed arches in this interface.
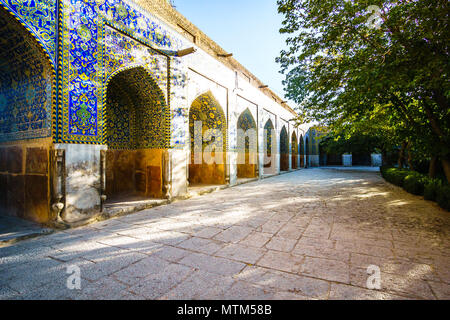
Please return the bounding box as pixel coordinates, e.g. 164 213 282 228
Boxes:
0 0 310 223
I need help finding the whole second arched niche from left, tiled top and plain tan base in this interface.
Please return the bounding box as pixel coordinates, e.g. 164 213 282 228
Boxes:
106 67 168 199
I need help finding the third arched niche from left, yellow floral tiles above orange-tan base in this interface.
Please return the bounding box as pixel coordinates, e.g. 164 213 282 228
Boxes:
189 92 227 185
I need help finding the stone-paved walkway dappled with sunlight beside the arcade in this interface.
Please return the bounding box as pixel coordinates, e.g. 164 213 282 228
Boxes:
0 169 450 299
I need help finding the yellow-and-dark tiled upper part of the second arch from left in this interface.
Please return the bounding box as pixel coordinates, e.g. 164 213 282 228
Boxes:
104 66 170 149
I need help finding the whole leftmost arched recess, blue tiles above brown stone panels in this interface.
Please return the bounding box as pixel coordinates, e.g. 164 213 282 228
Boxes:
0 6 53 222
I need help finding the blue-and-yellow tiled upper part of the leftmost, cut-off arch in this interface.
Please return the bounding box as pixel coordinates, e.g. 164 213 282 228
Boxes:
0 5 56 142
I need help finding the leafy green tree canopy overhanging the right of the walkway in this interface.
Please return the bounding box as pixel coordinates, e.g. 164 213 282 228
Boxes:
277 0 450 181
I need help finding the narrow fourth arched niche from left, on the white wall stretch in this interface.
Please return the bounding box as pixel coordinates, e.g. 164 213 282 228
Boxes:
237 109 258 178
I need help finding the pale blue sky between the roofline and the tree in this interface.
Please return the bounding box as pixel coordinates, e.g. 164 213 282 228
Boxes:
174 0 294 107
